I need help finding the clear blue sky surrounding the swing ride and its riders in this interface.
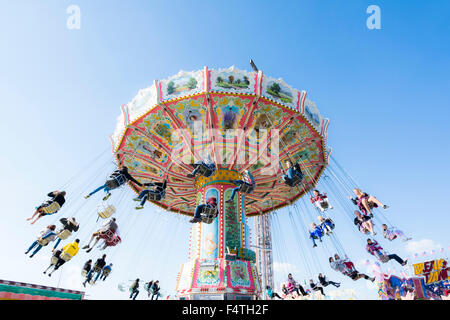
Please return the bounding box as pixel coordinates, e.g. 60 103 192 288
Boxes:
0 0 450 299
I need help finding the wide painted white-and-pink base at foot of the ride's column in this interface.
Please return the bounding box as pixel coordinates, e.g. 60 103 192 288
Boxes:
176 257 261 300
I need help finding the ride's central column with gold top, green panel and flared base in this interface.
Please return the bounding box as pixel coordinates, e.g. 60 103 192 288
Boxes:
177 169 261 299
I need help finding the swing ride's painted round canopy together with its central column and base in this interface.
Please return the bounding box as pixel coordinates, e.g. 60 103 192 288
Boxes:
111 67 329 300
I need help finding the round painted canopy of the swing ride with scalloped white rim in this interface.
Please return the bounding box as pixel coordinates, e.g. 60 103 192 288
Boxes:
111 67 329 216
